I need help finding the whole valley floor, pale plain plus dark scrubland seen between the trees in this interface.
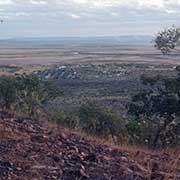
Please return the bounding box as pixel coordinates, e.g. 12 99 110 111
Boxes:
0 42 180 113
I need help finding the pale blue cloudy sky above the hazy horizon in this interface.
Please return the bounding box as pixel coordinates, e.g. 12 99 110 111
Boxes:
0 0 180 38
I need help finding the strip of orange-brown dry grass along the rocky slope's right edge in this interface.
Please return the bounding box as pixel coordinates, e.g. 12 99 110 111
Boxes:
66 129 180 180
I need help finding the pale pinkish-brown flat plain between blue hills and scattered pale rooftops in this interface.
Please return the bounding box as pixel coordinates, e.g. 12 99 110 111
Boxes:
0 44 180 65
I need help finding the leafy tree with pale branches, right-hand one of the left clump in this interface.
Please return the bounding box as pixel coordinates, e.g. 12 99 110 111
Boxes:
16 74 62 117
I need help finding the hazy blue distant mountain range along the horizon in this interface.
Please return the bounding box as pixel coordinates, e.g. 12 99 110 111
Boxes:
0 36 153 46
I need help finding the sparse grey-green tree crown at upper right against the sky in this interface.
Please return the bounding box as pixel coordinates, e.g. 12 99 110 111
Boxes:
154 26 180 55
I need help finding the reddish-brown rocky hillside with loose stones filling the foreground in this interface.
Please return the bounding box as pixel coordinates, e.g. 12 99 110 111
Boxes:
0 113 180 180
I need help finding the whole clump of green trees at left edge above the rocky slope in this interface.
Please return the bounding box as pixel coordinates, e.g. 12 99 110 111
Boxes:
0 74 62 118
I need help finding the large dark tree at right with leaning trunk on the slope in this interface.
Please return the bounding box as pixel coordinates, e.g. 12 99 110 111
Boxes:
129 68 180 148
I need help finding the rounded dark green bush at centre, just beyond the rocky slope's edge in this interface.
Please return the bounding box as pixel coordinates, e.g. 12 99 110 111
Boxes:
79 102 125 138
